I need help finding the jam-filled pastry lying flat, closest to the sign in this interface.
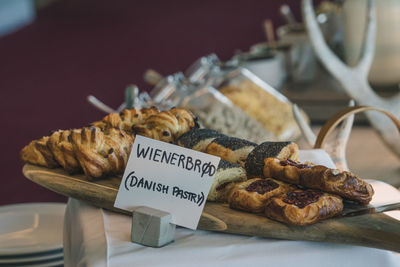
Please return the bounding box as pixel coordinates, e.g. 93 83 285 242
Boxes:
228 178 293 213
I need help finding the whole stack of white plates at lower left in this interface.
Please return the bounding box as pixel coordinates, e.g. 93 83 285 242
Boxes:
0 203 66 267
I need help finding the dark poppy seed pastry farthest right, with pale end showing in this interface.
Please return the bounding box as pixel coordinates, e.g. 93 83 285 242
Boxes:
245 142 299 177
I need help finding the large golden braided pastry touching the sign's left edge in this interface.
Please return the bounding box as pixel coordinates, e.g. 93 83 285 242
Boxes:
71 127 134 178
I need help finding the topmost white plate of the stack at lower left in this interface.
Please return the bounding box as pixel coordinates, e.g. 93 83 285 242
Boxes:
0 203 66 256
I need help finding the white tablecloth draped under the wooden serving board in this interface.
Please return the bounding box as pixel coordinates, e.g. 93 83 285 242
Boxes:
64 151 400 267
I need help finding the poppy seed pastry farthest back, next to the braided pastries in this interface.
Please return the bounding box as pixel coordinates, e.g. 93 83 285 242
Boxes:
177 128 225 152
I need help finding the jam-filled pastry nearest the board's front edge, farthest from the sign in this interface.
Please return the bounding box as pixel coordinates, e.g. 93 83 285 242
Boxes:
265 189 343 225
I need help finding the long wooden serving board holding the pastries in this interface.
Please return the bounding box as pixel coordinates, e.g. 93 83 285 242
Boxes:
23 164 400 252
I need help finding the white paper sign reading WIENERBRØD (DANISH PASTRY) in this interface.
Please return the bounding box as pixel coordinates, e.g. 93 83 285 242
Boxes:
114 135 220 229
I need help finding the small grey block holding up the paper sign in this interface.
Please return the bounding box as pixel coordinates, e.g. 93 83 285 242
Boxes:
131 206 176 248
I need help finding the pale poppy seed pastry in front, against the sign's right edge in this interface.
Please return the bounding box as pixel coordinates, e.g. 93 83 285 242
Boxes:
207 160 246 202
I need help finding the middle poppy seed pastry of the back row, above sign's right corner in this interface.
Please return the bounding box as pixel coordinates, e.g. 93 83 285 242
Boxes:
205 136 257 167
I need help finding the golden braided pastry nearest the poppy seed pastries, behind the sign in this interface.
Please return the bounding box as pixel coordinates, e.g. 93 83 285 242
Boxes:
133 108 199 143
